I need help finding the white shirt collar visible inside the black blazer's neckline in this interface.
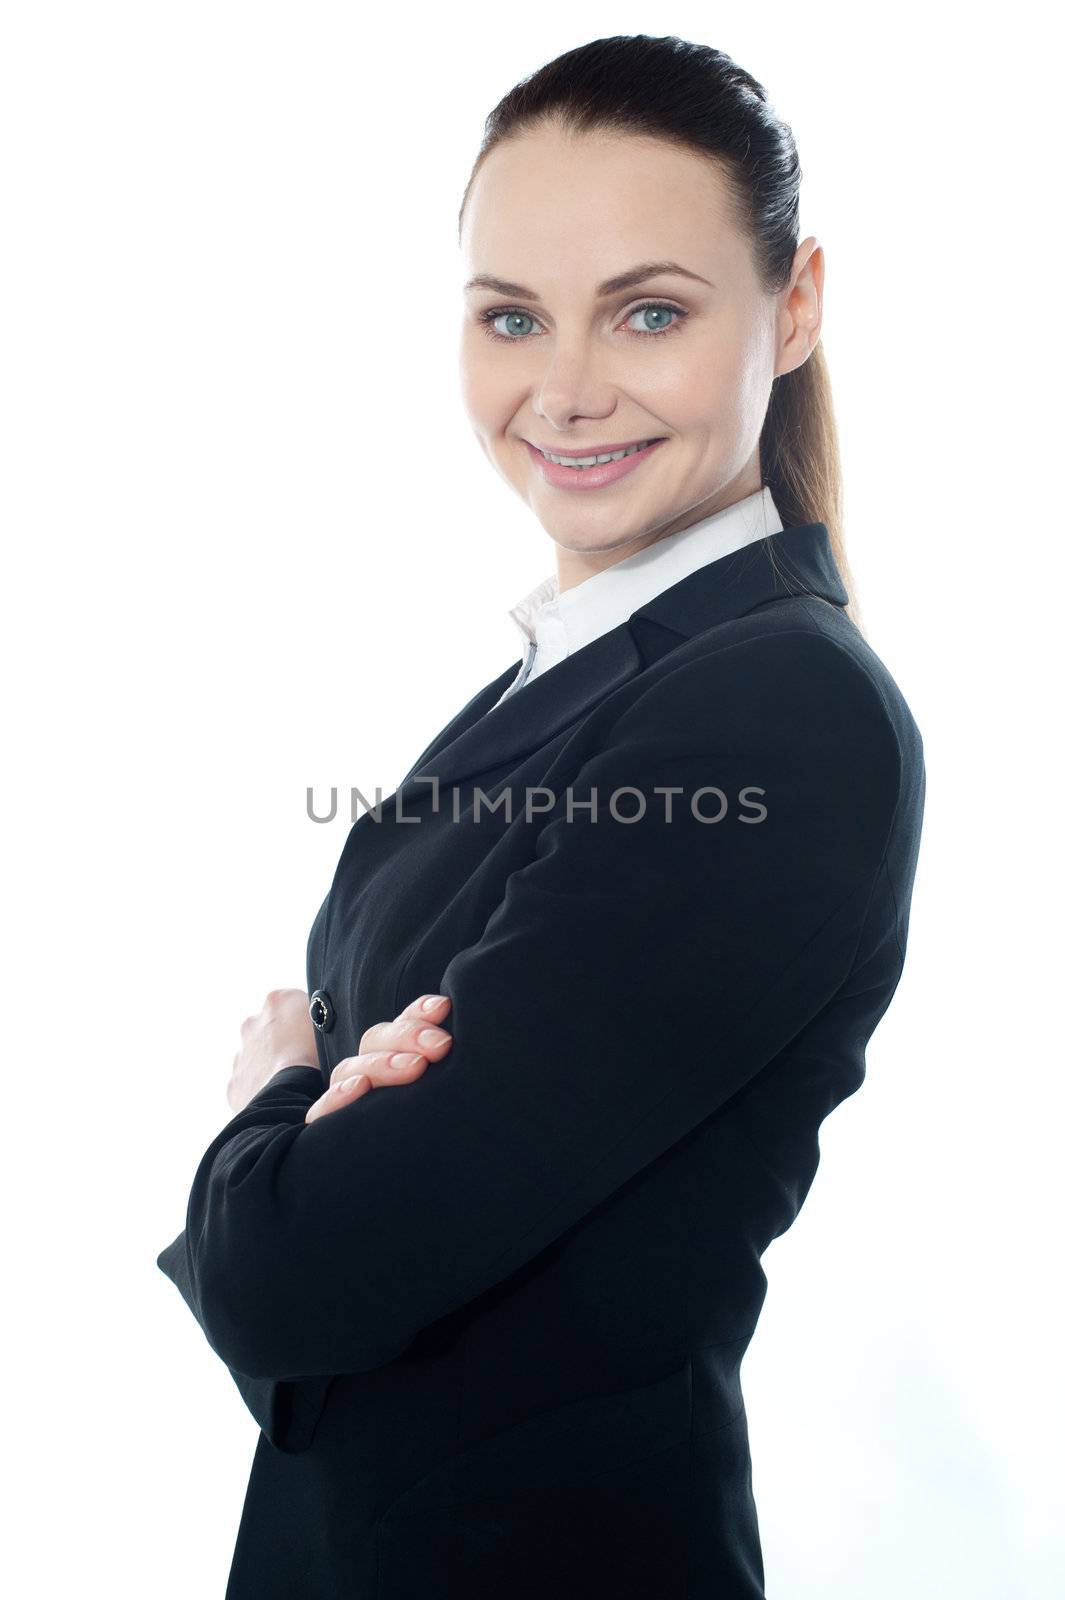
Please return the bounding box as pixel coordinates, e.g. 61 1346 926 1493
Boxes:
491 483 784 710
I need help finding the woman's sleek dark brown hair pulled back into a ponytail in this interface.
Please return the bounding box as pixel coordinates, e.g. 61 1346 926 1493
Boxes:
459 34 862 627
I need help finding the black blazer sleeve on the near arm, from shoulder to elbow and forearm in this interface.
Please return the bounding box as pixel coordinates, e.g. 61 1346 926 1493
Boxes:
157 630 902 1381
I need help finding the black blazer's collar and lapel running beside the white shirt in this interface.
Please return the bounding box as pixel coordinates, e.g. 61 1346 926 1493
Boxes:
382 522 848 818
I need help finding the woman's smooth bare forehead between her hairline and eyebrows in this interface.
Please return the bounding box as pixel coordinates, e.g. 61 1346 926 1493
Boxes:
462 130 745 283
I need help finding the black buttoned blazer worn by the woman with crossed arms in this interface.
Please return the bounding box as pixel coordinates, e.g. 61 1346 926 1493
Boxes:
158 523 924 1600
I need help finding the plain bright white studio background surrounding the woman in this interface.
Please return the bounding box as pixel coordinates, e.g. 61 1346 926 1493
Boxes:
0 0 1062 1600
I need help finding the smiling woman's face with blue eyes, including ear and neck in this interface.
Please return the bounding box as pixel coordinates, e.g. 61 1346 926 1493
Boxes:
461 130 824 587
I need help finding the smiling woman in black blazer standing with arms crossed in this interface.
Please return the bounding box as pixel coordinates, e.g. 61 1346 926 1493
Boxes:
158 35 924 1600
